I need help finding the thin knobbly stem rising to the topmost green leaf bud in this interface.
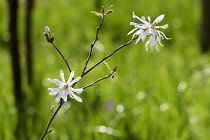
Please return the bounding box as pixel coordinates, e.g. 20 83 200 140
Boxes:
81 15 105 75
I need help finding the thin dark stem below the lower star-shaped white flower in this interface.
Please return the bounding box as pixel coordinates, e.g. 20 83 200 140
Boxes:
39 100 64 140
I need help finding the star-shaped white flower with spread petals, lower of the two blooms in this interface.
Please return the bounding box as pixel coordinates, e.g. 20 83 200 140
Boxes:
48 70 83 103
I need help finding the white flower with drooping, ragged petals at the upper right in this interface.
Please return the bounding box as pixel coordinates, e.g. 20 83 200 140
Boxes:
128 12 171 51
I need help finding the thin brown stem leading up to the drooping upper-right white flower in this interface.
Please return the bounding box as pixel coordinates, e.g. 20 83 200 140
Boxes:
81 36 138 77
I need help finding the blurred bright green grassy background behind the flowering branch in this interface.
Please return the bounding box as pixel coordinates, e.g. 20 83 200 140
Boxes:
0 0 210 140
